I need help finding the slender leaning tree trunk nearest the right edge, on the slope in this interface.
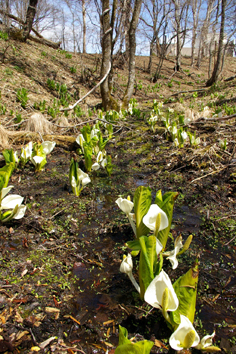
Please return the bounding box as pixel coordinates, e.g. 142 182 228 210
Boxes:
206 0 227 87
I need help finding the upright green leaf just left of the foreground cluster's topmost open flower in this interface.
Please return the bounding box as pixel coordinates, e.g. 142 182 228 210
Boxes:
134 186 152 239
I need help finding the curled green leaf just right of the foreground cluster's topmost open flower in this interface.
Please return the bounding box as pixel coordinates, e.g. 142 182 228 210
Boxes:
155 191 178 249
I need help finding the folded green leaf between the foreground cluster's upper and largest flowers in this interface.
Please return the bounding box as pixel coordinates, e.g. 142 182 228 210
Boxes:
139 236 157 299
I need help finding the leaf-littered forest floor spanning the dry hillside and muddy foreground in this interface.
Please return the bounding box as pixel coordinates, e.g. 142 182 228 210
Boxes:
0 34 236 354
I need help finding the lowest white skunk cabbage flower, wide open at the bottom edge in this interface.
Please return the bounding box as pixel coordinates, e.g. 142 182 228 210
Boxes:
169 315 200 350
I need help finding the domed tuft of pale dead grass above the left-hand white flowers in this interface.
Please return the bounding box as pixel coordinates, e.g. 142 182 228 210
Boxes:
25 113 53 135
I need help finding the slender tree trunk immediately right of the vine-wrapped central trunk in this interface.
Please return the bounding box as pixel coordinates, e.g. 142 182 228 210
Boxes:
123 0 142 107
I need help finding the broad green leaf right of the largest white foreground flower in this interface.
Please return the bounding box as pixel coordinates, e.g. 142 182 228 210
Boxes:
170 260 199 325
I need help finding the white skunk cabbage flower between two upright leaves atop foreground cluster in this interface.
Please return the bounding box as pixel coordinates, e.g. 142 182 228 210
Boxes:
143 204 169 234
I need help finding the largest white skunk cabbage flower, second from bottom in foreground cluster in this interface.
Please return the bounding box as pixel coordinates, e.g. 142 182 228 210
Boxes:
144 270 179 312
